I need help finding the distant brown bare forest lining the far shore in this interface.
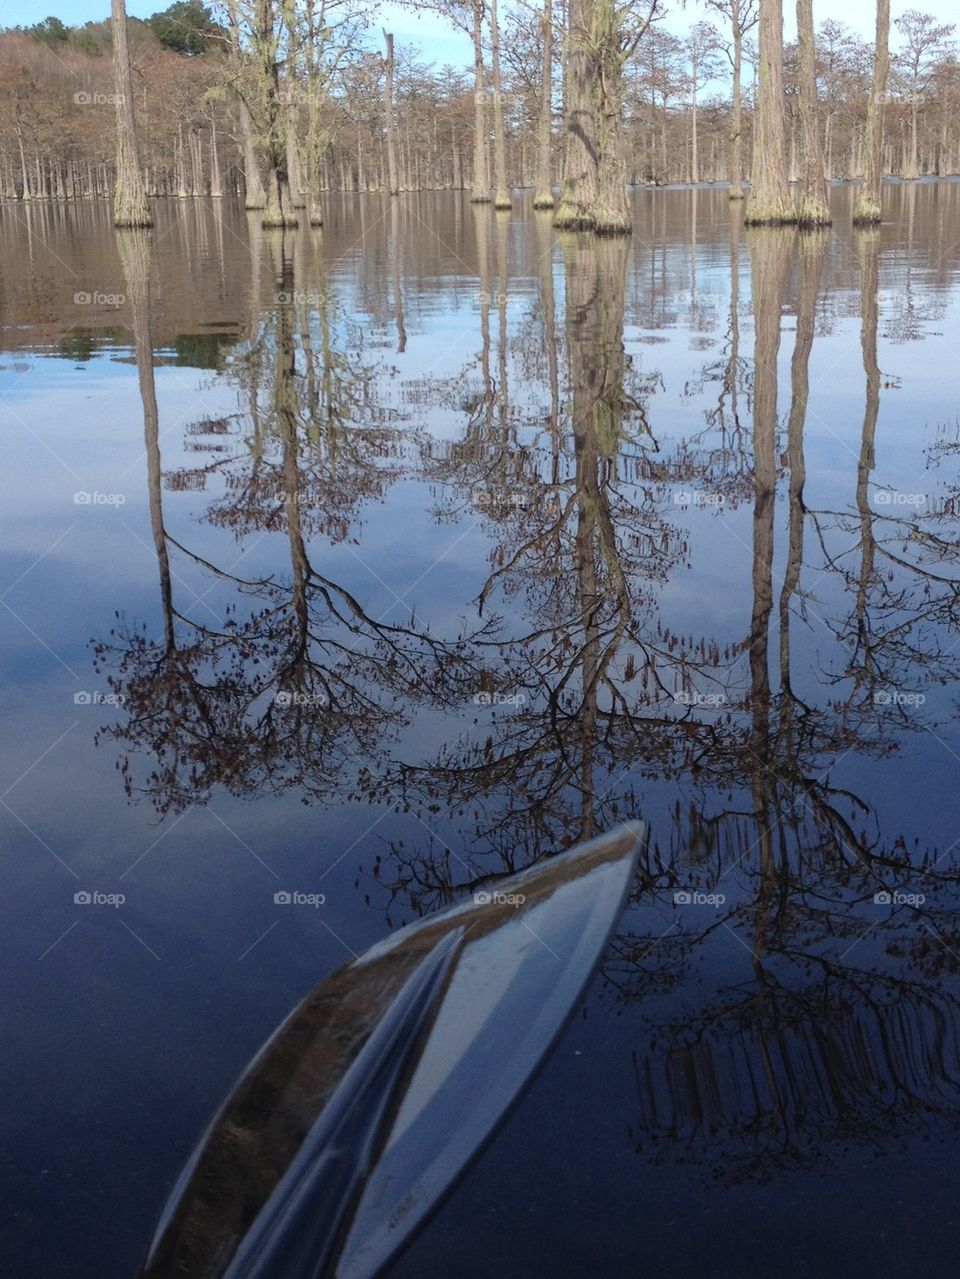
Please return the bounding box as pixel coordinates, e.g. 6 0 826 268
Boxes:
0 0 960 207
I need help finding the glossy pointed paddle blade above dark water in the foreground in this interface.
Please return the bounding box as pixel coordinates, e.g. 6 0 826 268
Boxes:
143 824 642 1279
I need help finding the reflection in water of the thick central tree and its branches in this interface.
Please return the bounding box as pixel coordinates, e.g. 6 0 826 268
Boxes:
381 237 741 909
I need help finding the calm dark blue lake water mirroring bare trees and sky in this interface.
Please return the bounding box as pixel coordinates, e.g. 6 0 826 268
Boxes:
0 182 960 1279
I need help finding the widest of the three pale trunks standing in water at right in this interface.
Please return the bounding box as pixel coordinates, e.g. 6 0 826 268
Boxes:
745 0 796 226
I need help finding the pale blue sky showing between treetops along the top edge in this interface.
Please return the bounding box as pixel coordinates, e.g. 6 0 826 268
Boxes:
7 0 960 67
